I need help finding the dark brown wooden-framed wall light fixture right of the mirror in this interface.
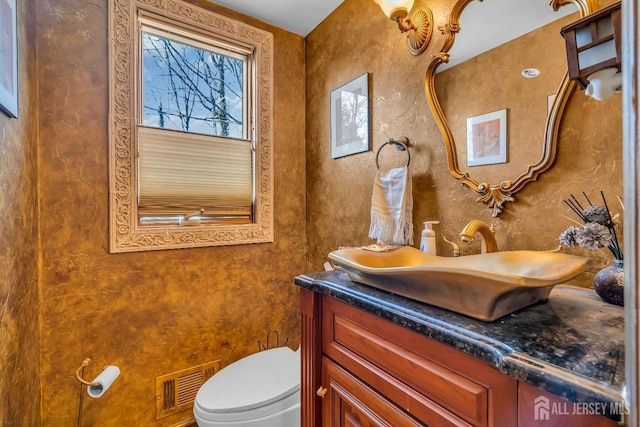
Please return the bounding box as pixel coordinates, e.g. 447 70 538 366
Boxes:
560 2 622 101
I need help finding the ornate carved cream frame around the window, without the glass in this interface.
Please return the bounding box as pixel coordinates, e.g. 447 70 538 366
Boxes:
109 0 273 253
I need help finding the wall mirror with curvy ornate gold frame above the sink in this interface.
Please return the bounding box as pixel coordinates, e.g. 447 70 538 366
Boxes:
425 0 597 217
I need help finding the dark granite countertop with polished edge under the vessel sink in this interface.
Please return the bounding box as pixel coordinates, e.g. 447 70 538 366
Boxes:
295 270 624 419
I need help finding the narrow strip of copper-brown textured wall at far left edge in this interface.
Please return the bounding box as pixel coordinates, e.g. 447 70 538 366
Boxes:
0 2 41 426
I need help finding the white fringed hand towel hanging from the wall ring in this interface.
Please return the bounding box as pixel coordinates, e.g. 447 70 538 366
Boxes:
369 166 413 246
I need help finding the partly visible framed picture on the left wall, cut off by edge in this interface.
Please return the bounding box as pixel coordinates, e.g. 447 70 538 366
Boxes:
0 0 18 117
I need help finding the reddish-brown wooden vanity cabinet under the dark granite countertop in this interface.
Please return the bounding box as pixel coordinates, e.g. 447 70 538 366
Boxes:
300 288 615 427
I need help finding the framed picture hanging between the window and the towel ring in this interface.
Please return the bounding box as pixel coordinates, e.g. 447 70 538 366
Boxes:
331 73 369 159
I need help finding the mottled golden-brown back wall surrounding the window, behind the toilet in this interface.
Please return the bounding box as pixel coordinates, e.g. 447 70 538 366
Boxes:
36 0 305 427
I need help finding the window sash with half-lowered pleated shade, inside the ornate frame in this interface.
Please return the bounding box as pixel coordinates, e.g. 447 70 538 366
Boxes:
137 17 253 227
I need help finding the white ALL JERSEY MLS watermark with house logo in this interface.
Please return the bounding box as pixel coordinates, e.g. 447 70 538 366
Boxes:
533 396 629 421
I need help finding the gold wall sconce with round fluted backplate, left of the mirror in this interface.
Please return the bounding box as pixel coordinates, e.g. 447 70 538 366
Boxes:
374 0 433 55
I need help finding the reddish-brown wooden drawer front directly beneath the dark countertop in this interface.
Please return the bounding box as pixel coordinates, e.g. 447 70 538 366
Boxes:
322 298 517 426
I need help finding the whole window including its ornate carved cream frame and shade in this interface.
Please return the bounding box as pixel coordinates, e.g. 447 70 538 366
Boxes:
109 0 273 252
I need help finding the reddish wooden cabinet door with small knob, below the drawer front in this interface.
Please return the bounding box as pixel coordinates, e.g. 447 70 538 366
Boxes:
320 357 425 427
